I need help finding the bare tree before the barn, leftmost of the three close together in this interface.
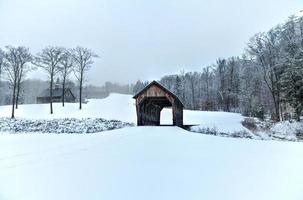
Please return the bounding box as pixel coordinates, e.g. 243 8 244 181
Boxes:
35 46 63 114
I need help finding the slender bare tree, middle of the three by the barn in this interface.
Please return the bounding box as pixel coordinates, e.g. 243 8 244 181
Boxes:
60 49 74 107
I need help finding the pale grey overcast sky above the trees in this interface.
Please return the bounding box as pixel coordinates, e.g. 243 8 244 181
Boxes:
0 0 303 85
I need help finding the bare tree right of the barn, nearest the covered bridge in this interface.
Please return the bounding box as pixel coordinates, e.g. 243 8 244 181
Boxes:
73 47 98 110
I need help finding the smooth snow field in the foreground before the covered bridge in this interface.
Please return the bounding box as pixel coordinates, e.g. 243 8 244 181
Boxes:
0 127 303 200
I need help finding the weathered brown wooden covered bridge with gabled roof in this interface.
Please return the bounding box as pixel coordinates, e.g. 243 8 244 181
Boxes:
133 81 183 127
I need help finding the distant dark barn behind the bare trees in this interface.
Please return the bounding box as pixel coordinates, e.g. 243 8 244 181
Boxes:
37 87 76 103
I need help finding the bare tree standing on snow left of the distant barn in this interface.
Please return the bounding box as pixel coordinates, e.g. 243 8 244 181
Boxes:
4 46 31 118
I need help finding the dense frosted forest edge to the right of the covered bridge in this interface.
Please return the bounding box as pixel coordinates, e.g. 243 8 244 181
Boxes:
134 16 303 121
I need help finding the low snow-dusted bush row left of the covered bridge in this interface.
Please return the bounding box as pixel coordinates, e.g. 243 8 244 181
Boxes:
0 118 133 133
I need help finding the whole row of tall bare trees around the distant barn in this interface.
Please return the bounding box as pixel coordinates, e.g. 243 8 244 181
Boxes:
0 46 98 118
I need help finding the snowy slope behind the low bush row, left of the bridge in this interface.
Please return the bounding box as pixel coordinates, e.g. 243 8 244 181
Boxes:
0 94 136 122
